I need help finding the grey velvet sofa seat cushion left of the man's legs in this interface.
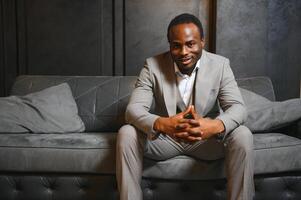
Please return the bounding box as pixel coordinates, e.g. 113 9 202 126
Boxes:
0 133 116 174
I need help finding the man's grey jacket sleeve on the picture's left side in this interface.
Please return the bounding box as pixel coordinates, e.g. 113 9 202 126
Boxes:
125 63 159 139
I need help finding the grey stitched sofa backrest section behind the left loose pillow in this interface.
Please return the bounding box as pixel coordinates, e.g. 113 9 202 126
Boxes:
11 75 137 132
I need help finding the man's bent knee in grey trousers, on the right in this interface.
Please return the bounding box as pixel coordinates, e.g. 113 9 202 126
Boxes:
229 126 253 153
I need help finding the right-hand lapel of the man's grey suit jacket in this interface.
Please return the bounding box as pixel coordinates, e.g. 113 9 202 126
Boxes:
195 50 211 115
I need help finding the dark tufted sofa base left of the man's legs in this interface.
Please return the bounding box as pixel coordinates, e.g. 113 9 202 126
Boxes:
0 174 118 200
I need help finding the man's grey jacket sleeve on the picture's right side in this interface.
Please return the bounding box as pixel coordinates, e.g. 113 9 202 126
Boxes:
217 59 247 138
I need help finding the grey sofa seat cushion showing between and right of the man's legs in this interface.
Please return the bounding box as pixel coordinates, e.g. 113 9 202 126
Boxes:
143 133 301 180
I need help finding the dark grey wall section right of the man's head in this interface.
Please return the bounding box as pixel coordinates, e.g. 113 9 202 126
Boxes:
216 0 301 100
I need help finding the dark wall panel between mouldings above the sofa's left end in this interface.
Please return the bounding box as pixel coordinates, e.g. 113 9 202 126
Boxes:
17 0 113 75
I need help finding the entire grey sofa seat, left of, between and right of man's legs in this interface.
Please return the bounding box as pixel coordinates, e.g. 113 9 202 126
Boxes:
0 133 301 180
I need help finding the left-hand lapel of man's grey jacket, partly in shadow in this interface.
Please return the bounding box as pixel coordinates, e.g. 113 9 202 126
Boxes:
161 53 177 116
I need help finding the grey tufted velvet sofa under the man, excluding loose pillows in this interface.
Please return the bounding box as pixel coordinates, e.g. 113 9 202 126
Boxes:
0 76 301 200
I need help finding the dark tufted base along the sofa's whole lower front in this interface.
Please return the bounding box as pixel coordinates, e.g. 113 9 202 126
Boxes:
0 173 301 200
